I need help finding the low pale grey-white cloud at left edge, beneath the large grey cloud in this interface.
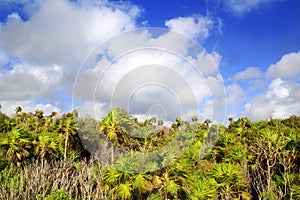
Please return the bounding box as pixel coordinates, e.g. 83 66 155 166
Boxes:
0 64 63 100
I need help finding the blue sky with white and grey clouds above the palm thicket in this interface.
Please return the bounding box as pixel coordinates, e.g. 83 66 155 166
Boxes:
0 0 300 122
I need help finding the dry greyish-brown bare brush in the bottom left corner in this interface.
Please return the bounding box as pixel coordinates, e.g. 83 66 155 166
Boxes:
0 160 107 200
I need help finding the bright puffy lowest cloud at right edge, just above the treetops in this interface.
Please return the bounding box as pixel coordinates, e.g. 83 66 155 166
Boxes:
245 78 300 121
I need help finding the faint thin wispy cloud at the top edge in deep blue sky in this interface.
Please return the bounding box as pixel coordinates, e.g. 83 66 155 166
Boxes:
221 0 274 16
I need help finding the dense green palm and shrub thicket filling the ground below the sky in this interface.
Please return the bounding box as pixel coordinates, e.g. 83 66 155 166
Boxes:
0 107 300 199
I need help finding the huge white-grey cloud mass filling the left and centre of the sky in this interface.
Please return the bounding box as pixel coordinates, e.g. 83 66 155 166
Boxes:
0 0 224 120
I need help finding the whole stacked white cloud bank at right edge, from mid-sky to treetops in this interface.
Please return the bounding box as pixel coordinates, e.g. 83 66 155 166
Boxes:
226 52 300 121
